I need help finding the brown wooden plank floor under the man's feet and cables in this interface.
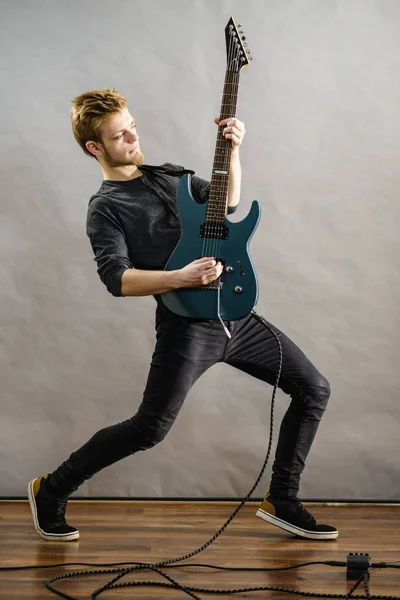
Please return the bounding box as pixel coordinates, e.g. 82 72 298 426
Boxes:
0 501 400 600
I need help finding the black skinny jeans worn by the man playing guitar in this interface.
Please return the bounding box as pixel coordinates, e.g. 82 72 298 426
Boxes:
47 306 330 500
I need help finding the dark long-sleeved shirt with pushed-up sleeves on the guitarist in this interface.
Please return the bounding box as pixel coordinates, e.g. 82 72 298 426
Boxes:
86 163 238 296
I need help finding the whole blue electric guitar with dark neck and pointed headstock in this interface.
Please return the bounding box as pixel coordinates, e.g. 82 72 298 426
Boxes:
161 18 260 328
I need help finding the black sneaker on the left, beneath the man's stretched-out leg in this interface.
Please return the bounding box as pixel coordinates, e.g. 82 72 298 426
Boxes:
28 475 79 542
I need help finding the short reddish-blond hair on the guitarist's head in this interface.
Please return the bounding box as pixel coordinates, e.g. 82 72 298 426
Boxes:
71 88 127 160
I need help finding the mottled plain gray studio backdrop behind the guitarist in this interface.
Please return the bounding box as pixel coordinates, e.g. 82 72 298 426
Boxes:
0 0 400 499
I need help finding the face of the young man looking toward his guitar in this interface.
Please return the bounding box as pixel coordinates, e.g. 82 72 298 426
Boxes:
99 108 144 167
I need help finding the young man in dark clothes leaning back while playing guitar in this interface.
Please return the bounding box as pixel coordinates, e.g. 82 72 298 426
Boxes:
28 89 338 541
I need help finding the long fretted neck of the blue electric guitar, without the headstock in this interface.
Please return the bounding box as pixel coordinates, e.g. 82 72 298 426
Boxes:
206 70 240 222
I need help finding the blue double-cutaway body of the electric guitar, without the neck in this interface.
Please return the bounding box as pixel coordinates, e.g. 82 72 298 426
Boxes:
162 175 260 321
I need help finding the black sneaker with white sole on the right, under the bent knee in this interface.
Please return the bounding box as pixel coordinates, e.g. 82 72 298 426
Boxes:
256 494 339 540
